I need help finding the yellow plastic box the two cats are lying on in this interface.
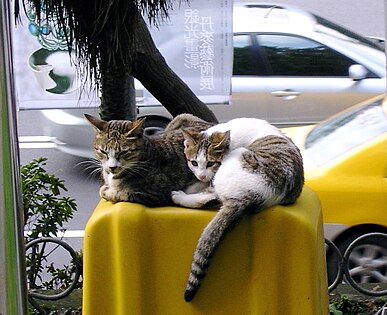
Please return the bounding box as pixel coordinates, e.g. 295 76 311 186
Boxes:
82 188 328 315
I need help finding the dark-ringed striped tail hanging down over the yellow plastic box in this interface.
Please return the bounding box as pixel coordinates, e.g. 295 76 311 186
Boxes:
184 200 258 302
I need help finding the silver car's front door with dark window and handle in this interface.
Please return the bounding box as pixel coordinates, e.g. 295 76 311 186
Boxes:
257 34 385 125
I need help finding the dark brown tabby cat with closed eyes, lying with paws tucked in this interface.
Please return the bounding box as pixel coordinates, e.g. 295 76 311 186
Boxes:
85 114 213 206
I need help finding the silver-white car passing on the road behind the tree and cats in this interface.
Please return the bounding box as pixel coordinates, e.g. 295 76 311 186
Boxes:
38 4 386 157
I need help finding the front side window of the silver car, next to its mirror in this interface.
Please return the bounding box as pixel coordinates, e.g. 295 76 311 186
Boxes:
258 34 355 77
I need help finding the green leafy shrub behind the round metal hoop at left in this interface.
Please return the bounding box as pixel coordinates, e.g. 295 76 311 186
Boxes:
20 158 80 290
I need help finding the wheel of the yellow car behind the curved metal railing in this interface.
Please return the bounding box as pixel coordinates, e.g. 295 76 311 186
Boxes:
327 233 387 285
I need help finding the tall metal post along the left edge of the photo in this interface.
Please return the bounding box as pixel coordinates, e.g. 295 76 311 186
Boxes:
0 0 27 315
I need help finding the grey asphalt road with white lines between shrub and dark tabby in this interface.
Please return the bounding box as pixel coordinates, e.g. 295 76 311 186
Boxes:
18 111 99 250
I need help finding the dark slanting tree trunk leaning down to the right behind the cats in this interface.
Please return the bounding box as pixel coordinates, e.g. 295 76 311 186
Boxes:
132 16 217 122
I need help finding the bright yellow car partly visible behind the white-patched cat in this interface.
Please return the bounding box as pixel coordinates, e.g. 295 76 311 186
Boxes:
283 95 387 283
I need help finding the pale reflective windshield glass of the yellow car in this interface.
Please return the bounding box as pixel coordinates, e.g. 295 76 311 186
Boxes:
305 100 387 166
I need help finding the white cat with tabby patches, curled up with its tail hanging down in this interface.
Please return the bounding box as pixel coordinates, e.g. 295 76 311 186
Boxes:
172 118 304 302
